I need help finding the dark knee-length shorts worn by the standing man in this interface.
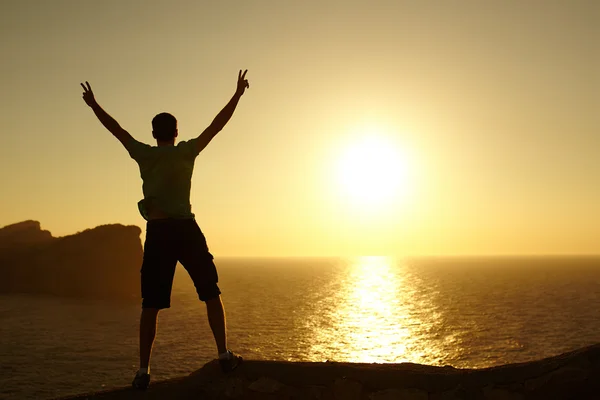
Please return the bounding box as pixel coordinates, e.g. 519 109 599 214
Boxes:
141 219 221 308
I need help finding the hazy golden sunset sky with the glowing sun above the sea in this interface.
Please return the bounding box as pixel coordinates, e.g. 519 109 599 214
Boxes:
0 0 600 257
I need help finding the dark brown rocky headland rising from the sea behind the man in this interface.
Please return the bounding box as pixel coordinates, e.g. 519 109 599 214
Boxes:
0 221 143 300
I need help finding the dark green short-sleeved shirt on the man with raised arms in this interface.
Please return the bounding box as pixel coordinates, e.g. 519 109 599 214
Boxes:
125 138 199 219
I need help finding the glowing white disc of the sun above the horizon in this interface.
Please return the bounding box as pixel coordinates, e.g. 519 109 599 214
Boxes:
337 133 411 209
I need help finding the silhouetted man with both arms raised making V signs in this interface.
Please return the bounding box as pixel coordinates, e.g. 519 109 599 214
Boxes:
81 70 250 390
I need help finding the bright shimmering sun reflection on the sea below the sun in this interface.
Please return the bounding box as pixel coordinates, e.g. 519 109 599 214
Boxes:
311 256 438 364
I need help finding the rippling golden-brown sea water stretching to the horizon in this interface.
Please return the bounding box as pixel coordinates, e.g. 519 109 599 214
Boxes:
0 257 600 399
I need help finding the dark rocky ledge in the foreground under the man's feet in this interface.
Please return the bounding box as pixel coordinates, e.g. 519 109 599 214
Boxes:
55 344 600 400
